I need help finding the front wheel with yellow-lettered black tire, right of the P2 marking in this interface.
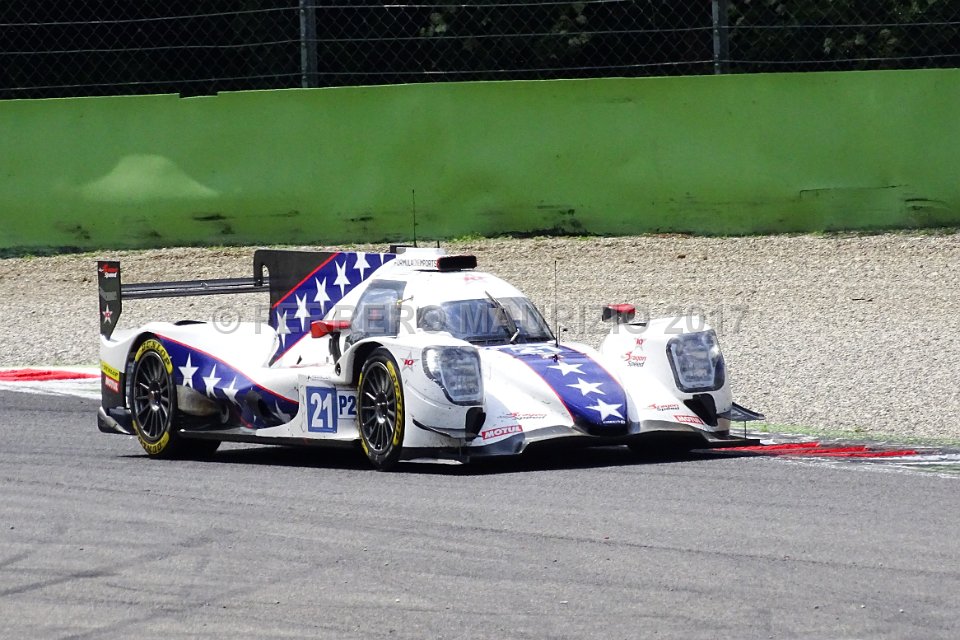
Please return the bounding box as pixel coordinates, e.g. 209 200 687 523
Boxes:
357 348 405 471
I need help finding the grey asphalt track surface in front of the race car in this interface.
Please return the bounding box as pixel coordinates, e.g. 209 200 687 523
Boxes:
0 392 960 639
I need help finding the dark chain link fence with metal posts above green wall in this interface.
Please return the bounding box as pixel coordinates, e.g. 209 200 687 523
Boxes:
0 0 960 99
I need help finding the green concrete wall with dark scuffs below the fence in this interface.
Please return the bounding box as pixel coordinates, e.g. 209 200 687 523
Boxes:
0 69 960 252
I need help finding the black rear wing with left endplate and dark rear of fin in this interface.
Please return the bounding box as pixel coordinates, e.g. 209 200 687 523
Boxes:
97 249 338 338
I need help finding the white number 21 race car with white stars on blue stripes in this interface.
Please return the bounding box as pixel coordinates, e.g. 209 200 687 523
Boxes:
97 247 762 469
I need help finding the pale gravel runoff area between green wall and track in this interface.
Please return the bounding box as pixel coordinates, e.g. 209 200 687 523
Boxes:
0 232 960 439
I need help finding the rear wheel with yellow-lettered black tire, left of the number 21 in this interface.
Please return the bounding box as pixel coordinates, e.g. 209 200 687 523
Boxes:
128 338 220 458
